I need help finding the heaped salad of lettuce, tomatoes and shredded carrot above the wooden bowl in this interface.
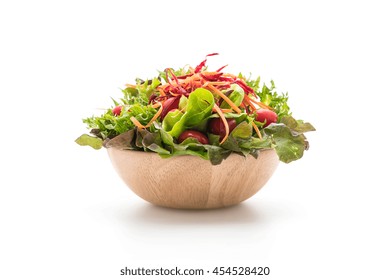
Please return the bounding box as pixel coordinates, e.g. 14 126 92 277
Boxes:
76 53 315 165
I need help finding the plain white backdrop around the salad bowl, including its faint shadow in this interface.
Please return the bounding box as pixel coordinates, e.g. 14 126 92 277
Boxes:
0 0 390 280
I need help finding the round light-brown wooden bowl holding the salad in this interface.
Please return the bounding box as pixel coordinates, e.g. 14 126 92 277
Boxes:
107 148 279 209
